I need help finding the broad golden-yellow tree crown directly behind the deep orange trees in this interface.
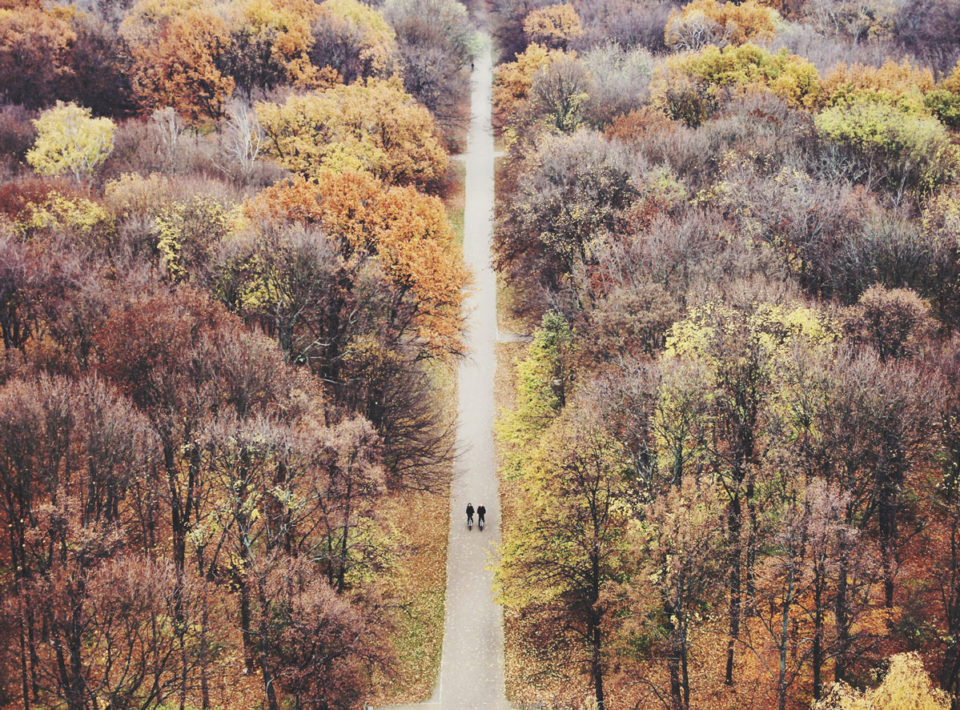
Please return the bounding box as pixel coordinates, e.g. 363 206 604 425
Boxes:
256 79 447 188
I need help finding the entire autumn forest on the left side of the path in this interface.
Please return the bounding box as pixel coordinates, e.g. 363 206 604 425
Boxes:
0 0 473 710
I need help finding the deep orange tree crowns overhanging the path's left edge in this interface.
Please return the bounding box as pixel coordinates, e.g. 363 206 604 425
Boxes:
245 170 468 353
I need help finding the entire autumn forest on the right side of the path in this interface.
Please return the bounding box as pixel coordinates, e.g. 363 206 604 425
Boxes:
492 0 960 710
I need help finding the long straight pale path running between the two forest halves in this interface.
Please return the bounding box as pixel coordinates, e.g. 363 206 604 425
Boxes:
434 37 508 710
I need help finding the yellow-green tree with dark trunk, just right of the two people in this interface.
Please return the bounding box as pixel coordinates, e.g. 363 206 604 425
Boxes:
497 409 628 707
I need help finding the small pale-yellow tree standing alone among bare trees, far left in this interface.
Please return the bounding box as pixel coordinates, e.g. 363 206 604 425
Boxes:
27 101 116 181
